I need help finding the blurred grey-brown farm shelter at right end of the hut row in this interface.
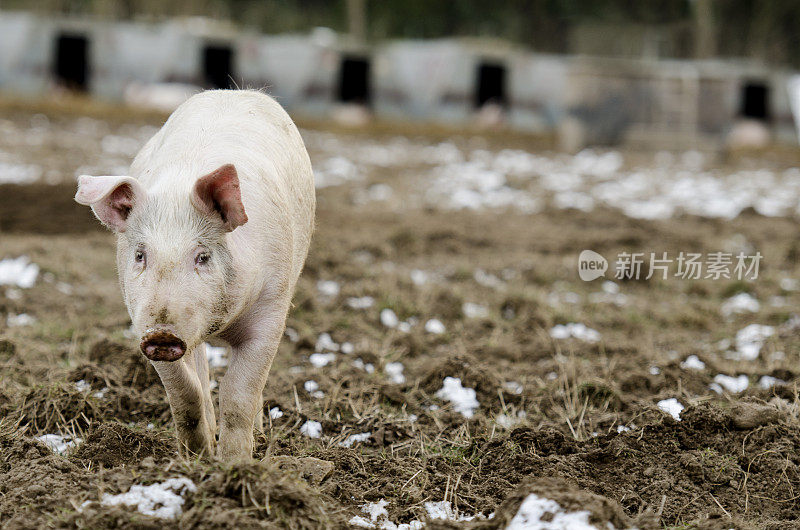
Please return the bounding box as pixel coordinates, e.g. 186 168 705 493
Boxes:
566 57 794 148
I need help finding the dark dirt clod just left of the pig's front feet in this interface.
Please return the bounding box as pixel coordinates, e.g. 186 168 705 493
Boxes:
71 423 177 467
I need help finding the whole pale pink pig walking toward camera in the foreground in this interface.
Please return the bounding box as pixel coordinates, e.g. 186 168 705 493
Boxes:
75 90 316 461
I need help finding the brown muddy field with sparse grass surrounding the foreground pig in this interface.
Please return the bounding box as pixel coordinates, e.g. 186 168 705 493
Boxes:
0 98 800 529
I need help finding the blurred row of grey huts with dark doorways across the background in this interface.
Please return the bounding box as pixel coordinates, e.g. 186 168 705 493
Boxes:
0 12 795 144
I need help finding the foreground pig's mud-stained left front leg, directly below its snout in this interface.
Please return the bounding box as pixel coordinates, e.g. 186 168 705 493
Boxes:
153 347 214 455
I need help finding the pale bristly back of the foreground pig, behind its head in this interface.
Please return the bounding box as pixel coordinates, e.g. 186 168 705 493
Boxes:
131 90 316 284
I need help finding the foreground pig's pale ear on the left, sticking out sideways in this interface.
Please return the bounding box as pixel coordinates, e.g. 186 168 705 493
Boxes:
75 175 144 232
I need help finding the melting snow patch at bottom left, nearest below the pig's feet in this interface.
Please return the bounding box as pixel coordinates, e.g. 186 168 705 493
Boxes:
100 477 197 519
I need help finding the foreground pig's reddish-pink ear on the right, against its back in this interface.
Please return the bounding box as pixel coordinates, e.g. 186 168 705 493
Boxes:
192 164 247 232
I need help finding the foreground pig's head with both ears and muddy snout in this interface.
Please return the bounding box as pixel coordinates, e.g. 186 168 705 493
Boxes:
75 164 247 361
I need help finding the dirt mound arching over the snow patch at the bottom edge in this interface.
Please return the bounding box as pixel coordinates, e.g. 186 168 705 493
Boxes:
476 478 633 528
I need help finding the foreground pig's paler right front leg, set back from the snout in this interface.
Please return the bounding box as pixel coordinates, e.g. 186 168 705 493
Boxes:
217 300 289 460
